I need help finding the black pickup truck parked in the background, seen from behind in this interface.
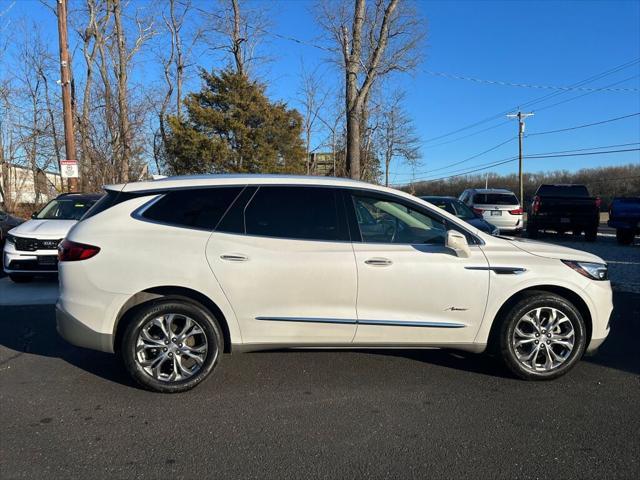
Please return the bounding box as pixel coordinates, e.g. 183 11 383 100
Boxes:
527 185 600 242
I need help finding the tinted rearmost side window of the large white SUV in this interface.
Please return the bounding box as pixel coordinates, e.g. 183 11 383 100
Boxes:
142 187 242 230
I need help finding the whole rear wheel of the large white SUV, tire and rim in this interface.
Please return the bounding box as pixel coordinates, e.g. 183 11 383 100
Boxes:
120 299 223 393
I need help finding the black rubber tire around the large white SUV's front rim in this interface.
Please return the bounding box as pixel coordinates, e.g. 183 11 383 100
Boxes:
499 291 587 380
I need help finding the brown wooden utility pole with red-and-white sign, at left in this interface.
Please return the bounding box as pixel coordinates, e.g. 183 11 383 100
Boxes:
57 0 78 192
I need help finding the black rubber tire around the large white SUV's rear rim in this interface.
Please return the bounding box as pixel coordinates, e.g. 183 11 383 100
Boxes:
118 298 224 393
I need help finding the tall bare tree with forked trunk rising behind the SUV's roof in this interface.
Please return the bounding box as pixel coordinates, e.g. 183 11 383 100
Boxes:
318 0 425 179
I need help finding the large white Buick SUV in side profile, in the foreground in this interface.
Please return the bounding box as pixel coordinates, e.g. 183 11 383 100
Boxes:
57 175 612 392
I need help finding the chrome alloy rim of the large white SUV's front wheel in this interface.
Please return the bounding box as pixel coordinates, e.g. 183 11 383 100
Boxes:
511 307 575 373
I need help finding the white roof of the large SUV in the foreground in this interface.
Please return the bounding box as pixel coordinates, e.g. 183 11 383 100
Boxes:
110 174 380 193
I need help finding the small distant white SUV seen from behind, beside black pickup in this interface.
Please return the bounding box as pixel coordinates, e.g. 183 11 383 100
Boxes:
459 188 523 233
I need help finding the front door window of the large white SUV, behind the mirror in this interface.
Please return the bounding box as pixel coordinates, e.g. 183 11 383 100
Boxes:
353 196 447 245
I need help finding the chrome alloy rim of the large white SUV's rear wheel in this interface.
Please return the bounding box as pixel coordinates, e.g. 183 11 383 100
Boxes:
135 313 208 382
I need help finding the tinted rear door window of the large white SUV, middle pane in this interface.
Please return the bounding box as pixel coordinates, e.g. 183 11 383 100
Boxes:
245 187 348 241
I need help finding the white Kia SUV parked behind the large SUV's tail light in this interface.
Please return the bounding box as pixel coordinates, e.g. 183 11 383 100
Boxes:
3 193 101 282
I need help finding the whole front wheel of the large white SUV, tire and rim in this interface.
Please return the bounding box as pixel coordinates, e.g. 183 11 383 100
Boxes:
500 292 586 380
